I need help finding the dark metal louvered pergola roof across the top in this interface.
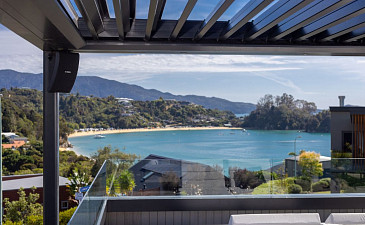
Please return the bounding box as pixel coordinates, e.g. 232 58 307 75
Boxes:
0 0 365 56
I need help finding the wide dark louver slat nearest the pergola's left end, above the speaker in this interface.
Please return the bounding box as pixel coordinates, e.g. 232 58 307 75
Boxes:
75 0 104 38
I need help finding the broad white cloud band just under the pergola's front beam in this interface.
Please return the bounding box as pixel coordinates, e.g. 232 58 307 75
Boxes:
80 54 301 82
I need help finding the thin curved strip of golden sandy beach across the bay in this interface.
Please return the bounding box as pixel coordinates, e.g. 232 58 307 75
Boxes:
69 127 242 137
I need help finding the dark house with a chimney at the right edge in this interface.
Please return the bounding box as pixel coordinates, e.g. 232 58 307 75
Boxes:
330 96 365 193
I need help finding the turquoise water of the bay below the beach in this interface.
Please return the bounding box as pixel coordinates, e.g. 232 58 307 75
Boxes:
70 130 330 169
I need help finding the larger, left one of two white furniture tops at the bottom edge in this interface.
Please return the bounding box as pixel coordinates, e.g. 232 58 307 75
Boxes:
229 213 321 225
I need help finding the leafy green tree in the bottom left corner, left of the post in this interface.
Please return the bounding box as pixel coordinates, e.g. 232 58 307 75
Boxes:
4 187 43 223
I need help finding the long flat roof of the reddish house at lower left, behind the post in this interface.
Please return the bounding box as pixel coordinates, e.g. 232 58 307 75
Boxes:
2 176 70 191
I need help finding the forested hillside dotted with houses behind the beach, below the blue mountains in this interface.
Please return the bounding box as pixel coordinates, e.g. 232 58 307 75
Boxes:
0 88 241 140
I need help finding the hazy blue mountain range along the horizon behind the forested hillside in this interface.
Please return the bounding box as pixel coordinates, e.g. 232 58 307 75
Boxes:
0 70 256 114
